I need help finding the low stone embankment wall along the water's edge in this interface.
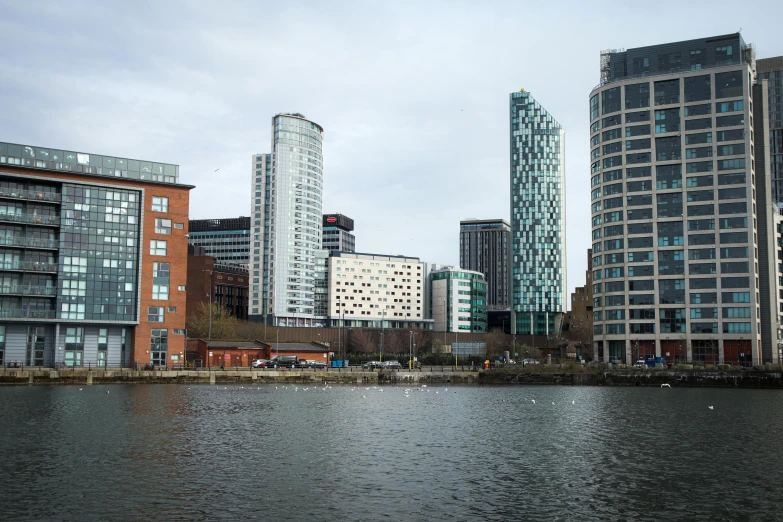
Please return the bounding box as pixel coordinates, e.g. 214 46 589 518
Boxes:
0 367 783 389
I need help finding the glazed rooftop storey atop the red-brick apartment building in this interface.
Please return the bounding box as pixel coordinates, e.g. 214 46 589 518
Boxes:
0 142 188 185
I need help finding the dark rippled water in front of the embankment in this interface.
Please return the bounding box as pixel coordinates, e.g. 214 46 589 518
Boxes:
0 385 783 521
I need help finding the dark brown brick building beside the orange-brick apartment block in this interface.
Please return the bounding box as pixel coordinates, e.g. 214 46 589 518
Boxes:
187 256 250 320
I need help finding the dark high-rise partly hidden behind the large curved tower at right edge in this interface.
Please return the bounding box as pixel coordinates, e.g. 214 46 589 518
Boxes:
756 56 783 203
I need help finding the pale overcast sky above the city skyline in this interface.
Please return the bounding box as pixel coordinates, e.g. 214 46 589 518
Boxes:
0 0 783 302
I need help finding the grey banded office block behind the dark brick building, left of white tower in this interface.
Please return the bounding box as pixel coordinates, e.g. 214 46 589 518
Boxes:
188 217 250 268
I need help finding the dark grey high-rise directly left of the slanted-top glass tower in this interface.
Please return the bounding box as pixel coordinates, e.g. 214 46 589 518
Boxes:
459 219 511 310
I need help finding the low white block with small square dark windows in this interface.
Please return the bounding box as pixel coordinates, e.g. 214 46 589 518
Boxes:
328 251 432 330
